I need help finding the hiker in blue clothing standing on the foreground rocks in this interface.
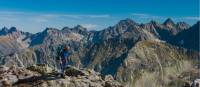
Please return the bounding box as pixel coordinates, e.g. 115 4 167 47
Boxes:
60 45 70 77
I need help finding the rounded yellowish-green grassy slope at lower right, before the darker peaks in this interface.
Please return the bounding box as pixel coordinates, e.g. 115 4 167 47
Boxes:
116 41 199 87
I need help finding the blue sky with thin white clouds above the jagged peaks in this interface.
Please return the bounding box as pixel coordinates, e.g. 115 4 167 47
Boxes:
0 0 200 33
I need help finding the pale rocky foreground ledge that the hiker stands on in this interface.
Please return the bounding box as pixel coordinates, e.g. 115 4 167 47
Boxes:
0 64 124 87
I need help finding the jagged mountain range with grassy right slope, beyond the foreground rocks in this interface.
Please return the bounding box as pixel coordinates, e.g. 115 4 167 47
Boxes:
0 18 199 87
